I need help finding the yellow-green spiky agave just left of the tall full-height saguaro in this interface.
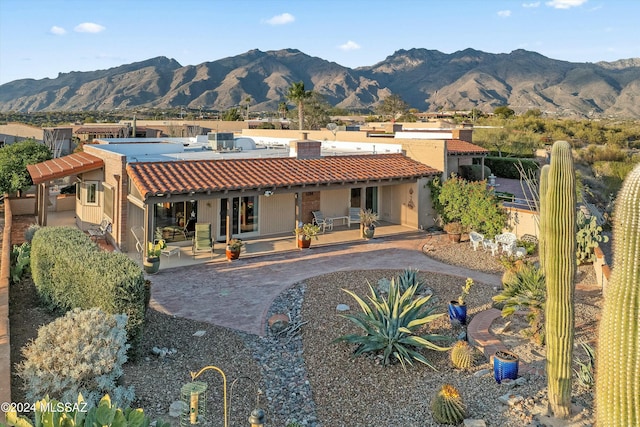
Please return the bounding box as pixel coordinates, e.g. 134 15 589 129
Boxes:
493 264 546 344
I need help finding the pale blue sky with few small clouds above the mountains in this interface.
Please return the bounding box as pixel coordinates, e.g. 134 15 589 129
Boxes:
0 0 640 84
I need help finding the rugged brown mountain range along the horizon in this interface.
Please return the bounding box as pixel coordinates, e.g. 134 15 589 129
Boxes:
0 49 640 118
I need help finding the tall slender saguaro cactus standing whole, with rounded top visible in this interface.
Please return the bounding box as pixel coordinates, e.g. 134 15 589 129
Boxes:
540 141 576 418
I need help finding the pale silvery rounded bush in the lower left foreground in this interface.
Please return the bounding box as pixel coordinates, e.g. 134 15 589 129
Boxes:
17 308 133 406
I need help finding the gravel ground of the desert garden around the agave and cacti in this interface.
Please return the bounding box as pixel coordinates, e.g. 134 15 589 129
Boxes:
10 237 601 427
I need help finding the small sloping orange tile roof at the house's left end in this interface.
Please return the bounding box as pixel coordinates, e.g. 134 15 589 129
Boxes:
27 152 104 184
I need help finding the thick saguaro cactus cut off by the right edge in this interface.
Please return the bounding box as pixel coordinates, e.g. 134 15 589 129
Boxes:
596 166 640 427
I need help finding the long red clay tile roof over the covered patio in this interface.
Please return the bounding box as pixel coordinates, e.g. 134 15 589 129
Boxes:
127 153 441 199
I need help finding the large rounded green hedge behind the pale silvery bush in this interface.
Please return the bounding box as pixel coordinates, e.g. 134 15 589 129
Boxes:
31 227 148 354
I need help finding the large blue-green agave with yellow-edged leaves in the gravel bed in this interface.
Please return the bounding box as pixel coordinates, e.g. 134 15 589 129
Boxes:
334 278 449 370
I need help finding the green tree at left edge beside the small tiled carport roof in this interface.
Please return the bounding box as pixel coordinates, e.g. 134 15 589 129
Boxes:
0 139 51 194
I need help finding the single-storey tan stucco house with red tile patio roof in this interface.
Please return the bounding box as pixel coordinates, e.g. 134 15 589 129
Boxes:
29 134 441 251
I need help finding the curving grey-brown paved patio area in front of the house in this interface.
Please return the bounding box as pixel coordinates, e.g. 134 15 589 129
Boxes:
150 232 500 335
